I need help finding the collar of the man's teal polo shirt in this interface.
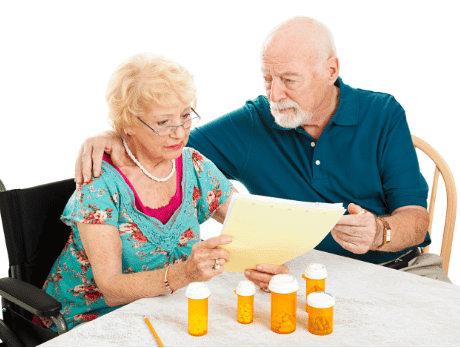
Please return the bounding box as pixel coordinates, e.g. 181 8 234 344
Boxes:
267 76 359 130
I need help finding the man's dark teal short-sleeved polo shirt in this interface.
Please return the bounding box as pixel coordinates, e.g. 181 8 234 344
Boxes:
188 78 430 263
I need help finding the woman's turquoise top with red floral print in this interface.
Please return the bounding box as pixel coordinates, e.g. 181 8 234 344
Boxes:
42 148 233 330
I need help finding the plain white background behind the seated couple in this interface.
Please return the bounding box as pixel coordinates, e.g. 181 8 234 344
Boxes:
0 0 460 308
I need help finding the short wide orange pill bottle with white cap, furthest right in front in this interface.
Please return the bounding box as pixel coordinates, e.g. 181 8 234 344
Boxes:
307 292 335 336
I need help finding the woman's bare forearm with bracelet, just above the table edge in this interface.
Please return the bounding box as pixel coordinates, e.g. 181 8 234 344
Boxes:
100 262 191 307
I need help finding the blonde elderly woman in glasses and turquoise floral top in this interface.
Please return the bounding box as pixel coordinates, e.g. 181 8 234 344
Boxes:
42 54 235 328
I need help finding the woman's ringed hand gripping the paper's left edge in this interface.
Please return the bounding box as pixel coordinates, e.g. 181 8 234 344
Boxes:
185 236 232 282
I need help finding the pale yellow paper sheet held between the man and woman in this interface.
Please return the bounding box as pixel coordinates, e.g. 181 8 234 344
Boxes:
221 193 345 273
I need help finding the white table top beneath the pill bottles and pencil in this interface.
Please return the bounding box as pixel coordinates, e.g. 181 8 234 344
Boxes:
42 250 460 347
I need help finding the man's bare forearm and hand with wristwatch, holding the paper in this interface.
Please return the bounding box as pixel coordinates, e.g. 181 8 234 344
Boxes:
331 203 429 254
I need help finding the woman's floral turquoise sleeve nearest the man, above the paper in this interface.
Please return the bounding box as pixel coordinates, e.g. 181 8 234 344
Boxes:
191 150 233 224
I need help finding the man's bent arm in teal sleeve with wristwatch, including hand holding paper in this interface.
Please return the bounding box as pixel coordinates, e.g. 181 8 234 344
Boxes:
331 96 429 254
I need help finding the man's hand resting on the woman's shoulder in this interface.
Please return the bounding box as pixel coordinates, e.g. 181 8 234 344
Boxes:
75 130 129 184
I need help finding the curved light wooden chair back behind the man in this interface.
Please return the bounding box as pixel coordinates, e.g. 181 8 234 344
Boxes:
412 135 457 274
